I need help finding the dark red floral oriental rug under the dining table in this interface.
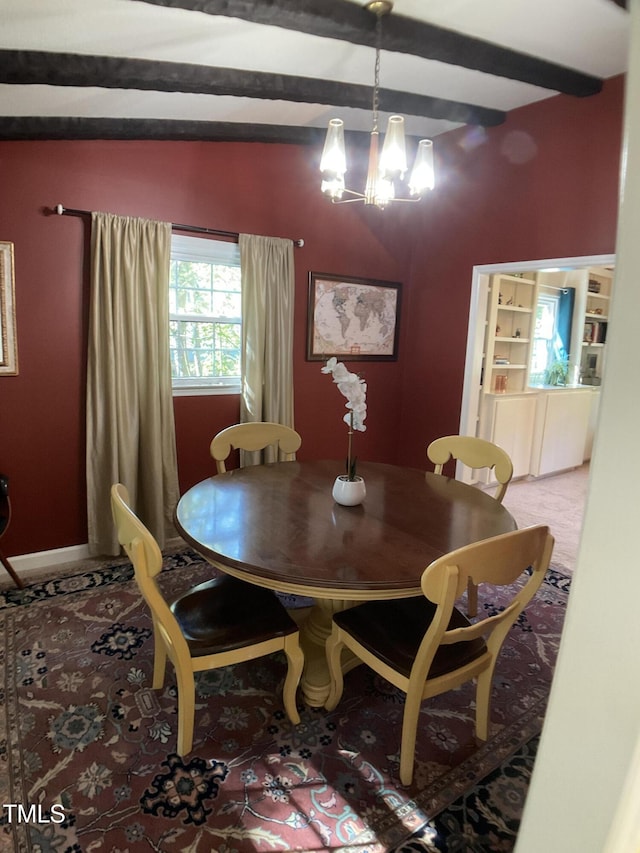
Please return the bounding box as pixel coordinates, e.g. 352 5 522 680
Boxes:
0 550 569 853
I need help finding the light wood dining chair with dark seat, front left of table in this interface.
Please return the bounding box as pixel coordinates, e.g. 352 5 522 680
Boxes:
111 483 304 755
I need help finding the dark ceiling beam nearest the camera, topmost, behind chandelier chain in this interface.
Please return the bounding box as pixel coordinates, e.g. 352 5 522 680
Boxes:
136 0 602 97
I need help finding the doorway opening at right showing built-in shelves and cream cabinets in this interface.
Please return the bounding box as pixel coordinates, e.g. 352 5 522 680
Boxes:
456 255 615 568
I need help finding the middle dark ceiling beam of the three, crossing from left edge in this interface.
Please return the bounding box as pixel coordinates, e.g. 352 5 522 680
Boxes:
0 50 505 127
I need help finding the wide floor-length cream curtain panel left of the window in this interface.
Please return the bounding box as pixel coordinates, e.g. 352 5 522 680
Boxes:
87 213 179 554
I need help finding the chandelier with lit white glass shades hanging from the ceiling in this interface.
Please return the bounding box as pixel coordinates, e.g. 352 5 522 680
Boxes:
320 0 434 208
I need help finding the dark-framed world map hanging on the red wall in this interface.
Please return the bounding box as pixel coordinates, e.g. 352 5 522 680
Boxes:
307 272 402 361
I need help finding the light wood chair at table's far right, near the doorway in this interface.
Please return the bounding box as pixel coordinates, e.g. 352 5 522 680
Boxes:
427 435 513 616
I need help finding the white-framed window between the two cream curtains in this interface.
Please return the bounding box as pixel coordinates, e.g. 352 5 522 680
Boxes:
169 235 242 394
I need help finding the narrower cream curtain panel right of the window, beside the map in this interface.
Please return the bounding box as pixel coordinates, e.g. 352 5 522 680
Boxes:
238 234 295 465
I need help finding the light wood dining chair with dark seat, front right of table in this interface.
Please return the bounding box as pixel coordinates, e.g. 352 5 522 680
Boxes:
325 525 554 785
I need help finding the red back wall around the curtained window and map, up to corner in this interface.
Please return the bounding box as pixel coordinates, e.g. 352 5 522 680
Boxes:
0 141 413 555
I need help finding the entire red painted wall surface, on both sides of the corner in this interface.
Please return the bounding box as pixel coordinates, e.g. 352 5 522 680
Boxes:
0 80 622 555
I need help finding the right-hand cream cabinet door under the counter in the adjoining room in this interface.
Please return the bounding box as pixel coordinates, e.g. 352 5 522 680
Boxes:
531 388 591 477
